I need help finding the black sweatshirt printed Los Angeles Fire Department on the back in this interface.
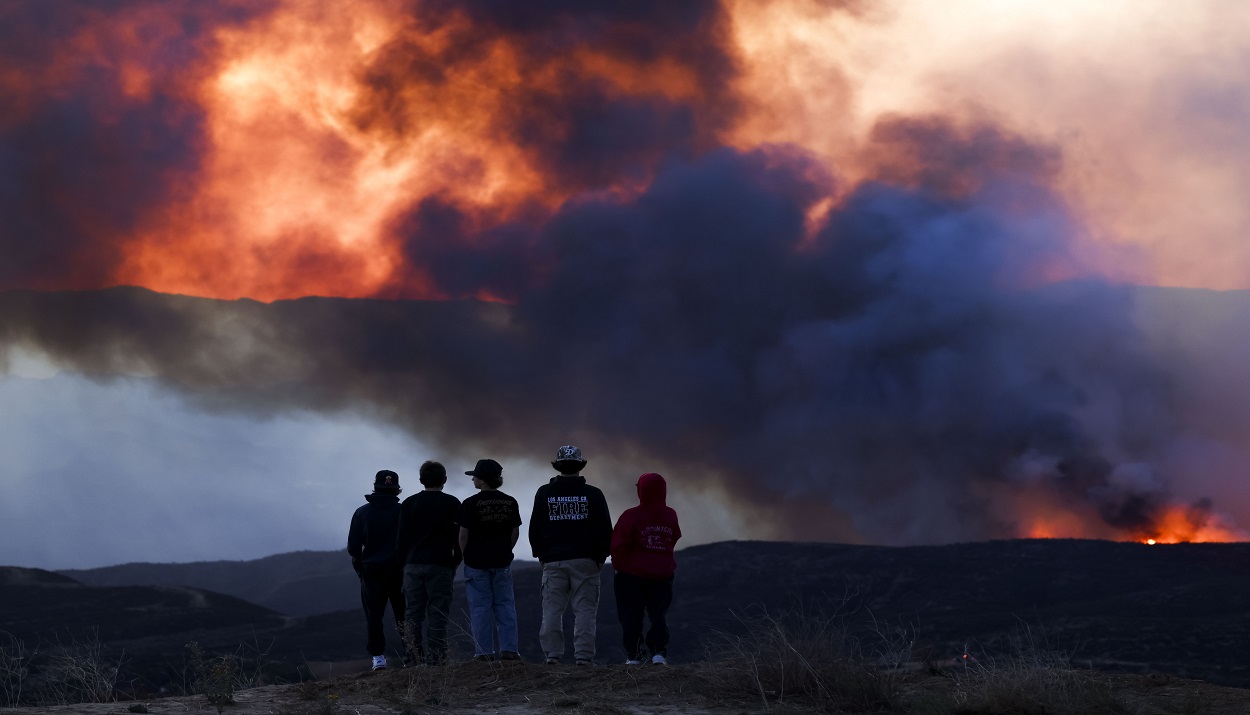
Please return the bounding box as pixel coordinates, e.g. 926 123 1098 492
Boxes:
530 475 613 564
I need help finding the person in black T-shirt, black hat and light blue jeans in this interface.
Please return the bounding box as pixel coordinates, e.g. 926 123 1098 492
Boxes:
456 459 521 660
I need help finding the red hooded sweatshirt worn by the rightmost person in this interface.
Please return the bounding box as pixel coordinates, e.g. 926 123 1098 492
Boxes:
613 473 681 579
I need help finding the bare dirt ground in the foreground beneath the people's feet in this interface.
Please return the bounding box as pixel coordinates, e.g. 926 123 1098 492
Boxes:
6 663 1250 715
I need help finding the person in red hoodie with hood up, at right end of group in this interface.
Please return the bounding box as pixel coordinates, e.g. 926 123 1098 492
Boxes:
613 473 681 665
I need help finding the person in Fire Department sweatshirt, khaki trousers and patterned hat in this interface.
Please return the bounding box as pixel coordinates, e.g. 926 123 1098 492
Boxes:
529 445 613 665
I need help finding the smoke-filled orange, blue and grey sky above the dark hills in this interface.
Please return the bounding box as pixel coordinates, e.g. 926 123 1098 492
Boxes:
0 0 1250 568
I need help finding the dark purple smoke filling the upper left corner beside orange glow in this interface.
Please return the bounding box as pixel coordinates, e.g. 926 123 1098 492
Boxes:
0 0 276 288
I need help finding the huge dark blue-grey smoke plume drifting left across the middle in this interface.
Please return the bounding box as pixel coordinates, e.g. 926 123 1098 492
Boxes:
0 118 1206 543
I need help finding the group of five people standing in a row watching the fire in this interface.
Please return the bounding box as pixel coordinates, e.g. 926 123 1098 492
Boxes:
348 445 681 670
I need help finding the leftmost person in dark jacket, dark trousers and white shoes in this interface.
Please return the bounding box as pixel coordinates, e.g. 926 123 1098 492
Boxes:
348 469 404 670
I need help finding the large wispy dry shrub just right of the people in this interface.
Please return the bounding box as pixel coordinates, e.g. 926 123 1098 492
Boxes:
703 611 893 713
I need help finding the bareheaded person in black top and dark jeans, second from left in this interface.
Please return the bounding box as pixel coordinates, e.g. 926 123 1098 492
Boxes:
395 461 460 665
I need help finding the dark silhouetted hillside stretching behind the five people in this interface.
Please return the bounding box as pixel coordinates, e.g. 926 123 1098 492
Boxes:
14 540 1250 686
